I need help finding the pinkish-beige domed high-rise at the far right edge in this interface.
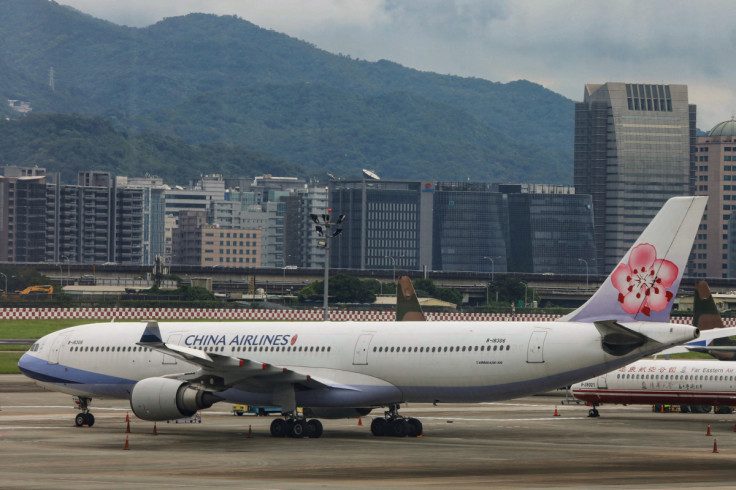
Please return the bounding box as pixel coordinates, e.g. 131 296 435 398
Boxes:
692 119 736 277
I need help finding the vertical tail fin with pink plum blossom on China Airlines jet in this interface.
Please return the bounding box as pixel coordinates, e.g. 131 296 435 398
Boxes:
560 197 708 322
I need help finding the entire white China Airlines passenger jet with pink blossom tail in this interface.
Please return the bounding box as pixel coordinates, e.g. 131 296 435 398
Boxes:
18 197 706 437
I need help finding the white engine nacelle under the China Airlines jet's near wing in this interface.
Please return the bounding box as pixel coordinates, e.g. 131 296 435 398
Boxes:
130 378 220 421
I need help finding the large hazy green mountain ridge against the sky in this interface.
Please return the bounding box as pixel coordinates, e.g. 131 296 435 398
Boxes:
0 0 574 183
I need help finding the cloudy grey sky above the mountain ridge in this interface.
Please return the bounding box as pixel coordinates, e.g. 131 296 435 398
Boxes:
57 0 736 131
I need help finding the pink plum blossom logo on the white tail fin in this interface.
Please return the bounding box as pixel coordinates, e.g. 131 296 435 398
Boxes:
611 243 678 316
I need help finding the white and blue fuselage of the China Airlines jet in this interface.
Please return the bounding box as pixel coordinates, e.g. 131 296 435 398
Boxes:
19 322 695 407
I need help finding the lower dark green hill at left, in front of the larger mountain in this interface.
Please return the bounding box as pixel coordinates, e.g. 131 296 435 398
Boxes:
0 114 306 184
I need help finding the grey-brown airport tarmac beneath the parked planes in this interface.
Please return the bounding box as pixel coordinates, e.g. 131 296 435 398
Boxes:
0 375 736 489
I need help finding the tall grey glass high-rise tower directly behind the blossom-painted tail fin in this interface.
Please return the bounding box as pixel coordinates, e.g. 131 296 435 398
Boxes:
575 82 696 270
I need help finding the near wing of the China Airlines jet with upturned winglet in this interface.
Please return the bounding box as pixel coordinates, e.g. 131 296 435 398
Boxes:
138 322 346 391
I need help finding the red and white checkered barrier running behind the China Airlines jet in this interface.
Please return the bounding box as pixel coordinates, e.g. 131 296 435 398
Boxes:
0 308 720 327
